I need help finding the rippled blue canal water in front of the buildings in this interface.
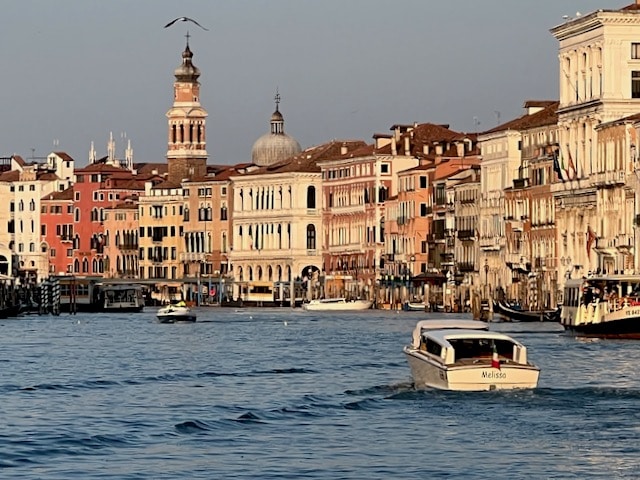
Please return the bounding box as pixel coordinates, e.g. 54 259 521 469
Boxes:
0 308 640 480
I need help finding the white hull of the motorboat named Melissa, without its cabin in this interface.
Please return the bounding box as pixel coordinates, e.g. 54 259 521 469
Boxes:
404 347 540 391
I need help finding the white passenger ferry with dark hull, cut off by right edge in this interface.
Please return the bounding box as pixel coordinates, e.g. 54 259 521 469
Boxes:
560 275 640 339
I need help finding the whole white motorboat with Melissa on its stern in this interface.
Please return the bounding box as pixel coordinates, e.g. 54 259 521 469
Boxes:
404 320 540 391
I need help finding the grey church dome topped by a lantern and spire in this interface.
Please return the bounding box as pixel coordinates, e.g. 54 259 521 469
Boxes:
251 94 302 167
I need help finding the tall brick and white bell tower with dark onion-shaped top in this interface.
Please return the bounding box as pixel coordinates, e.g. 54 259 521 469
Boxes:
167 33 207 183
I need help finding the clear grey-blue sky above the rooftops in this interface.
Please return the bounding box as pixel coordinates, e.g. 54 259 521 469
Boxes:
0 0 620 166
